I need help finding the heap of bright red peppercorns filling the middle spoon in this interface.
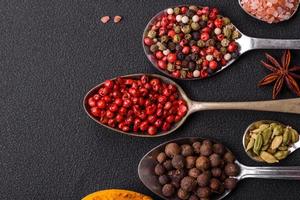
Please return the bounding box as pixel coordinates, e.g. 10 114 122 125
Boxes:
87 75 188 135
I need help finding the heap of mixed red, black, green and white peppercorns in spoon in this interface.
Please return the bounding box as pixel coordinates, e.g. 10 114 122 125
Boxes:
144 6 240 79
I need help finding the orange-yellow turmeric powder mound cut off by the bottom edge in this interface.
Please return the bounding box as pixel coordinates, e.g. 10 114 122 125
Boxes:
82 189 152 200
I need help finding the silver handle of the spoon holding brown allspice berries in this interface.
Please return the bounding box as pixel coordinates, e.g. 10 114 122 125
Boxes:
239 165 300 180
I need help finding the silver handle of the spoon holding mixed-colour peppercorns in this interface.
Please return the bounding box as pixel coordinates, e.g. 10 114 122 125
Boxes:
251 38 300 49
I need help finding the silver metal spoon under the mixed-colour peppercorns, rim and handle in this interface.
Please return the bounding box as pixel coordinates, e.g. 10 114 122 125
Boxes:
142 5 300 80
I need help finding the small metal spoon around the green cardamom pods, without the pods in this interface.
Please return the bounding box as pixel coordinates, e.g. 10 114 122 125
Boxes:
243 120 300 162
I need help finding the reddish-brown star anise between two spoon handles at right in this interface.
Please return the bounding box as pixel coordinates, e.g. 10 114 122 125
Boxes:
258 50 300 99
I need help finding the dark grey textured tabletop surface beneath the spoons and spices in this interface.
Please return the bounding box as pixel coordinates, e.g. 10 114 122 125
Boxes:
0 0 300 200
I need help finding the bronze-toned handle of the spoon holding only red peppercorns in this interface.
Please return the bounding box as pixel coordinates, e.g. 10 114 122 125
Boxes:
191 98 300 114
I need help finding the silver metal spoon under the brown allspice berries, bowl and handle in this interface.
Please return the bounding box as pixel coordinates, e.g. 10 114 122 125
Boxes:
138 137 300 200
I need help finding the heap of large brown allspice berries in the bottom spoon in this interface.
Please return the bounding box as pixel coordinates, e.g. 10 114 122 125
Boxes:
154 140 240 200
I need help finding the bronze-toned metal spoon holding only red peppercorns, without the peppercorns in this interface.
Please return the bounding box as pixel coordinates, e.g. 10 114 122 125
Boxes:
83 74 300 137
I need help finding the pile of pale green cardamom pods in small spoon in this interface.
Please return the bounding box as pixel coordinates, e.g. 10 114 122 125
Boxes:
245 123 299 163
